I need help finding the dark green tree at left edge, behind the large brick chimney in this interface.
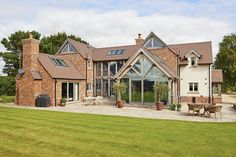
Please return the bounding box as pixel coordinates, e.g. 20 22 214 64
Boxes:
0 31 40 76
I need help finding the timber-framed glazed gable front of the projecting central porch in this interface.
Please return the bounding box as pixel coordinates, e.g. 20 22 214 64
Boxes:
123 56 168 104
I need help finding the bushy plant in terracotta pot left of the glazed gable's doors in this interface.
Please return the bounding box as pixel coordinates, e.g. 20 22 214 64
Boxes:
112 81 127 108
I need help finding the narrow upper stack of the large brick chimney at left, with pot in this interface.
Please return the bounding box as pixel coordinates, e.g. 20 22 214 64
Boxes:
22 32 40 71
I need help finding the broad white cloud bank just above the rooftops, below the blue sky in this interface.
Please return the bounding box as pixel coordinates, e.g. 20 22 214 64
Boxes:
0 8 232 74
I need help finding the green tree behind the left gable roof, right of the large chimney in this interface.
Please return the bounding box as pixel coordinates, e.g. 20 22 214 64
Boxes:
40 32 88 54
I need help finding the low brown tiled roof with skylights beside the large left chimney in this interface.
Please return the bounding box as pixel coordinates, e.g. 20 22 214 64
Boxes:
38 53 85 80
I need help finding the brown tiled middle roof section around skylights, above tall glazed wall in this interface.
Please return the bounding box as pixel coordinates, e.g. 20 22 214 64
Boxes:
92 45 140 61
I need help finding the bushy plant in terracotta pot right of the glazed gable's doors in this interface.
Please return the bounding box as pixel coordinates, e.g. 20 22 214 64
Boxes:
153 82 169 110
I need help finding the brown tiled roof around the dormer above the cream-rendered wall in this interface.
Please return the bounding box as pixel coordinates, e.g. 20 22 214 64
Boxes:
169 41 213 64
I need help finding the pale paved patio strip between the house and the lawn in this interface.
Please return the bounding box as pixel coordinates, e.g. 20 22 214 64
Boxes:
1 103 236 122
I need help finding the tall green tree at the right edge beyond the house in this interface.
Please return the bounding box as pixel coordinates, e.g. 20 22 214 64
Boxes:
214 33 236 91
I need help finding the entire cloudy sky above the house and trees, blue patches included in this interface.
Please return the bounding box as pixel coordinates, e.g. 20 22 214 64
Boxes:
0 0 236 74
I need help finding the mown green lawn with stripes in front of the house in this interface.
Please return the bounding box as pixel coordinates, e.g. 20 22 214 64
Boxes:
0 107 236 157
